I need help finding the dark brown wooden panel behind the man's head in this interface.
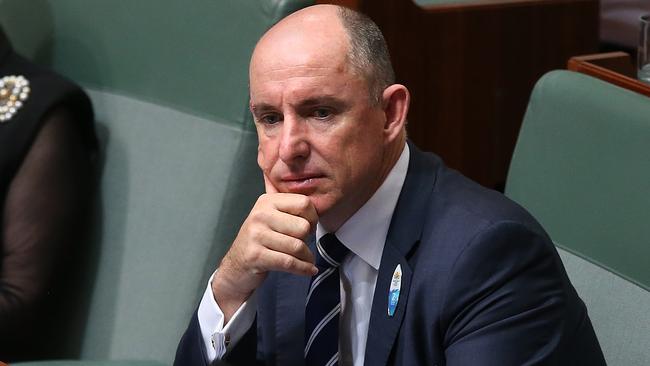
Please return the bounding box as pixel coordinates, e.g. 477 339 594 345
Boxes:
319 0 598 188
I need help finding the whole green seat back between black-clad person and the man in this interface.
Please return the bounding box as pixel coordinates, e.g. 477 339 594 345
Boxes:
0 0 310 363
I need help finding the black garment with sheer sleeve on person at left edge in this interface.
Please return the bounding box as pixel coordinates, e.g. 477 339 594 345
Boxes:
0 29 96 361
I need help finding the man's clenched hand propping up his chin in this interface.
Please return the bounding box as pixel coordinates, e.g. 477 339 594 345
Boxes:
212 176 318 324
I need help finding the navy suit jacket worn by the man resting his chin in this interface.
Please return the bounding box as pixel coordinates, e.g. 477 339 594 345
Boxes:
175 144 605 366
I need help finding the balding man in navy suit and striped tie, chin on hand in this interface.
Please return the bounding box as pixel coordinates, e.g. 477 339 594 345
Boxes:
176 5 604 366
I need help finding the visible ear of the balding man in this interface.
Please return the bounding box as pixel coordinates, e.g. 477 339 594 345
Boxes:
382 84 411 142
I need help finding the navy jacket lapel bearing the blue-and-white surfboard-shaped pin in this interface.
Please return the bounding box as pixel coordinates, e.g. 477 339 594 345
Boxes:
364 143 436 365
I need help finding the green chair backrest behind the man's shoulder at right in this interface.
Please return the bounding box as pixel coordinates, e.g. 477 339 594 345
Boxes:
506 71 650 365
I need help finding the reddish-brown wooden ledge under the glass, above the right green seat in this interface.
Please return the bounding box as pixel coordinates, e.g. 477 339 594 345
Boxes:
568 52 650 97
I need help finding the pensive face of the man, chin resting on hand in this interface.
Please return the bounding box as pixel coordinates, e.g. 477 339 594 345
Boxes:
250 25 386 229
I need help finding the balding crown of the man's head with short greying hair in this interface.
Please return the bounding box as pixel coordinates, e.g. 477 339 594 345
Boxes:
250 5 395 103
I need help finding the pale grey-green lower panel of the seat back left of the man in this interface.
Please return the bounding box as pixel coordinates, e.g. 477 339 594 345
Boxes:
12 90 262 358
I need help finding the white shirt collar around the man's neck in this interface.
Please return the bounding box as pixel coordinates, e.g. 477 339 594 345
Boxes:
316 144 409 270
